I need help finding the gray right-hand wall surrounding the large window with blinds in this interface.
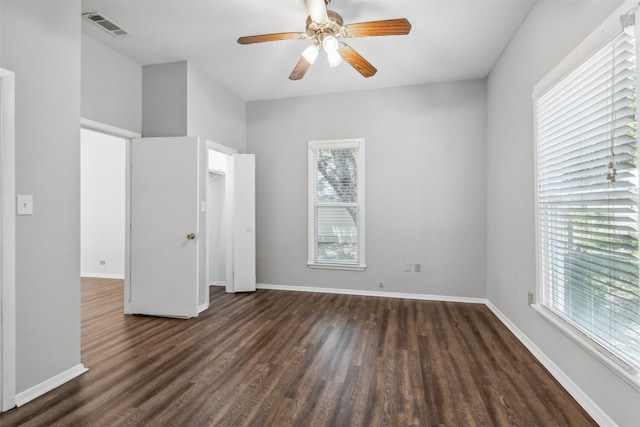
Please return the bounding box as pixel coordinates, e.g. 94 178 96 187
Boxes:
487 1 640 426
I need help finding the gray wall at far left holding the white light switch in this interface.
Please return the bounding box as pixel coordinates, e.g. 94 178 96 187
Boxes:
0 1 80 392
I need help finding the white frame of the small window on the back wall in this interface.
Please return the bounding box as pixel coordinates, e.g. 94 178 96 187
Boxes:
307 138 366 271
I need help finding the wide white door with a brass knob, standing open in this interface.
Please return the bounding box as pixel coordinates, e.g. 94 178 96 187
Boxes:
125 137 206 317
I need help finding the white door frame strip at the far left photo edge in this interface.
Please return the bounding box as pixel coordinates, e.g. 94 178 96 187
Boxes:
0 68 16 412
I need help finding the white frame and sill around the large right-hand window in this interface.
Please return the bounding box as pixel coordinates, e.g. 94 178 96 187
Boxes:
531 0 640 391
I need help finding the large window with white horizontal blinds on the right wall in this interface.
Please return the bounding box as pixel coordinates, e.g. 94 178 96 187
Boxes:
534 27 640 374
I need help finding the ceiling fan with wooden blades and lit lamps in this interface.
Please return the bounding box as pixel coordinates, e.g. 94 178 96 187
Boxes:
238 0 411 80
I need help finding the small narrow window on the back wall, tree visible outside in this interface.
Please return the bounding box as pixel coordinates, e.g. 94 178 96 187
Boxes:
308 139 364 269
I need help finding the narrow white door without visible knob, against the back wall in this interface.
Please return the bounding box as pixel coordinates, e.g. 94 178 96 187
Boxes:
226 154 256 292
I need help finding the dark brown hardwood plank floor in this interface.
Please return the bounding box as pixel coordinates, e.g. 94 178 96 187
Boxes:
0 279 596 426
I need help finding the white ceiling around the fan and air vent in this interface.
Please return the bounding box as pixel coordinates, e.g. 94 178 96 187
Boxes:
82 0 534 101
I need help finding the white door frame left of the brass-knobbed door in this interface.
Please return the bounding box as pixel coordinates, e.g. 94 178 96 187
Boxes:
80 118 142 313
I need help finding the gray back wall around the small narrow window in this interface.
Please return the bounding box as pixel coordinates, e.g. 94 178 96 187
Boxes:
247 80 486 297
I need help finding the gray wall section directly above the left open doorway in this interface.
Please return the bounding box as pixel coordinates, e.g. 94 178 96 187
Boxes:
82 34 142 133
